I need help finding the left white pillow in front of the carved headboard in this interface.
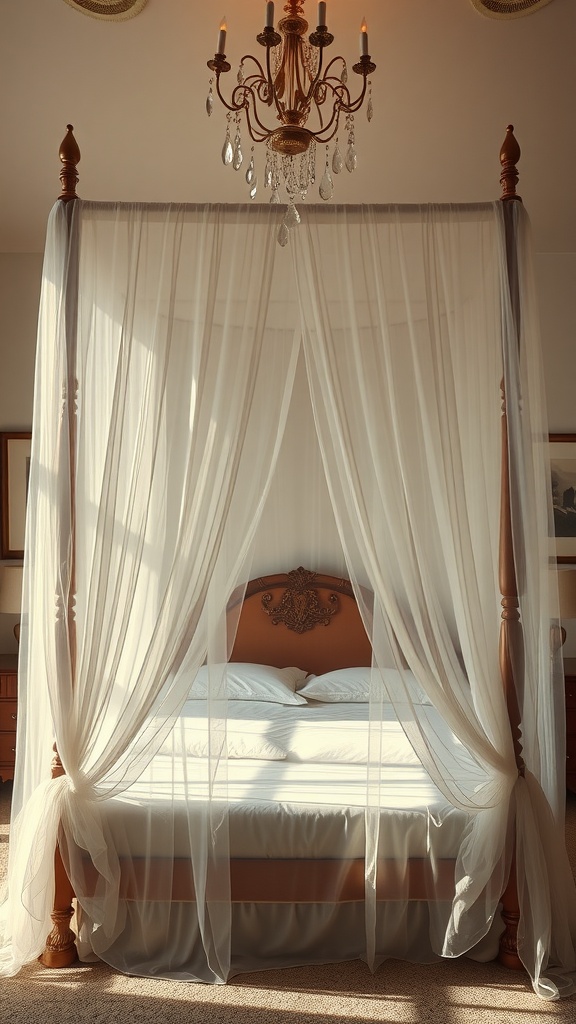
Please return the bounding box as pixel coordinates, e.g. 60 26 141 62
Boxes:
190 662 306 705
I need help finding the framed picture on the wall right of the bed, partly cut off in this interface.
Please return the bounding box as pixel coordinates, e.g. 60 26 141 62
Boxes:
548 434 576 562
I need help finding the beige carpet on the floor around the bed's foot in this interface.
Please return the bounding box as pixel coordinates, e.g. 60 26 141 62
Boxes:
0 784 576 1024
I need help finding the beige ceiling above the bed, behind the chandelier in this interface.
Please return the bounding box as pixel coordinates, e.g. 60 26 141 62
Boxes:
0 0 576 253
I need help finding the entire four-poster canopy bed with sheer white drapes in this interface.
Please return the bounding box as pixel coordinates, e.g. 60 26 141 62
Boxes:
0 121 576 998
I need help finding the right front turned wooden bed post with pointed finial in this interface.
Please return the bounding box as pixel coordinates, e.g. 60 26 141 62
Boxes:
498 125 525 971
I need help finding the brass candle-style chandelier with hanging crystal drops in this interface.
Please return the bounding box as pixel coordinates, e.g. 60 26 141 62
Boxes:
206 0 376 245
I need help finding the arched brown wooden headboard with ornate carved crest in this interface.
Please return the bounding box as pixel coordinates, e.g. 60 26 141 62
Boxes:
226 566 372 675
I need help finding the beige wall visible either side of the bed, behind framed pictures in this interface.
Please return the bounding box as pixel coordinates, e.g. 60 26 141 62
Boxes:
0 253 576 655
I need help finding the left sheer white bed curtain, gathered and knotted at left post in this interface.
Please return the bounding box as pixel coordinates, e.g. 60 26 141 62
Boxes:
3 197 297 981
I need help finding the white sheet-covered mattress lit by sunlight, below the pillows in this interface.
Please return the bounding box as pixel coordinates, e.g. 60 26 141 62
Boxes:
101 700 483 858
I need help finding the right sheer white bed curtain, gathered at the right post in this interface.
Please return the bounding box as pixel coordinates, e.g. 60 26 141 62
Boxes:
295 204 576 997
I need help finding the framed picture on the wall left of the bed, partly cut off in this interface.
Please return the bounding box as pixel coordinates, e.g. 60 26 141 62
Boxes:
0 431 32 559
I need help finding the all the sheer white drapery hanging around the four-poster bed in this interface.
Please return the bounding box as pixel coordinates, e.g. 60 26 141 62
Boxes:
2 195 576 997
